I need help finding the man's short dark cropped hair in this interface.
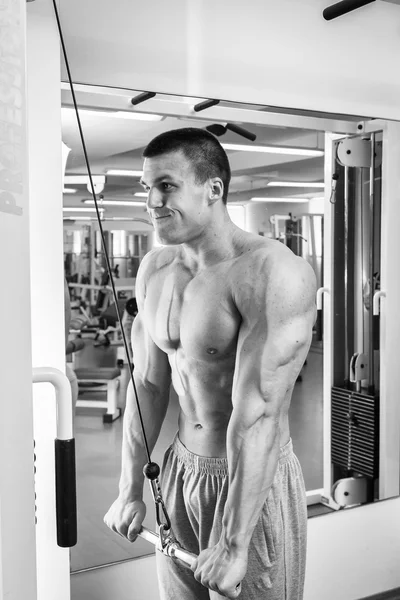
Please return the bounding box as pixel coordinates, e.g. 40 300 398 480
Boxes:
143 127 231 204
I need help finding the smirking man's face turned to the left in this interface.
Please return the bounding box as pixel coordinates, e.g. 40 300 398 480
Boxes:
141 151 210 245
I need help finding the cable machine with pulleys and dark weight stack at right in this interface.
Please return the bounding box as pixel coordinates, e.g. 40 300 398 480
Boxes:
320 133 382 509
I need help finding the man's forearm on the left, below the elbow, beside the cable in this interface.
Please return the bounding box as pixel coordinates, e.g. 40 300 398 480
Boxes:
119 375 169 501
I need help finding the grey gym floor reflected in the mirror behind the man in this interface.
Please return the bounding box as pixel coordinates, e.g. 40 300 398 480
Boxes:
71 340 323 572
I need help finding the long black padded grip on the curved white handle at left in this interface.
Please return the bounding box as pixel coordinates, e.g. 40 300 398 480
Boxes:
55 439 77 548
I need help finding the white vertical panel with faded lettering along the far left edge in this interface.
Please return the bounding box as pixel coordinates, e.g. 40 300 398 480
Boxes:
0 0 36 600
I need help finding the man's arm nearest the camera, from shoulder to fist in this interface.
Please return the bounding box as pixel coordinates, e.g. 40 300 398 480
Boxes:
195 257 316 598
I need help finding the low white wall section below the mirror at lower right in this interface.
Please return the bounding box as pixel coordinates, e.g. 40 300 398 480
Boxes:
304 498 400 600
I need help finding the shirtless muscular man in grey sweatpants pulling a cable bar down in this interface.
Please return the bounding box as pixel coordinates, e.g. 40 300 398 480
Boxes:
104 128 316 600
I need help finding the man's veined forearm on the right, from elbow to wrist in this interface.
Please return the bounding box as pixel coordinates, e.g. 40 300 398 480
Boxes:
222 410 280 549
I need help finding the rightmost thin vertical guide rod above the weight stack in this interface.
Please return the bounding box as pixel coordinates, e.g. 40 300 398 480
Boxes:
368 133 375 393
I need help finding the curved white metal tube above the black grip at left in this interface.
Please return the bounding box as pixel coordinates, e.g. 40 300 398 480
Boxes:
32 367 73 440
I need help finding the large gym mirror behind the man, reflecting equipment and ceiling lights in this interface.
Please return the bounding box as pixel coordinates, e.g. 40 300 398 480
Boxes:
61 82 394 571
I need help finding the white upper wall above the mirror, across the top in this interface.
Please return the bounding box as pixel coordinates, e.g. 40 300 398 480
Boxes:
57 0 400 119
